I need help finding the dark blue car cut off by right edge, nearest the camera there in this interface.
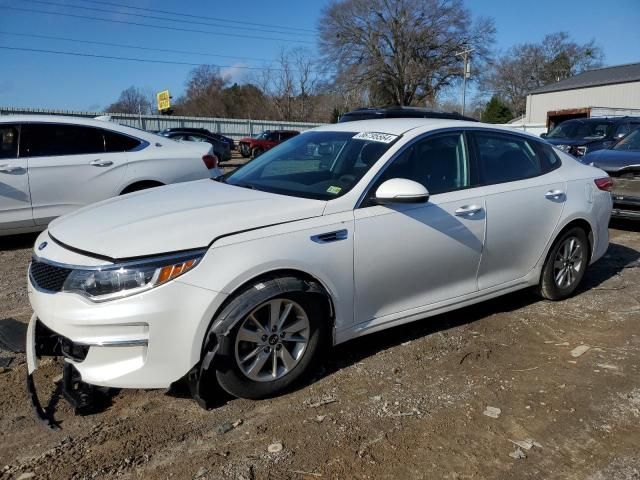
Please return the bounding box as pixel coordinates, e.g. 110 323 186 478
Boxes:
582 128 640 219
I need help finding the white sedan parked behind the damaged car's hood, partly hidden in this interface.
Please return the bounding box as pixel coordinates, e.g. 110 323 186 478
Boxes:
0 115 222 236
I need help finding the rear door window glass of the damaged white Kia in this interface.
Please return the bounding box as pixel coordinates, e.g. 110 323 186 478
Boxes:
474 132 544 185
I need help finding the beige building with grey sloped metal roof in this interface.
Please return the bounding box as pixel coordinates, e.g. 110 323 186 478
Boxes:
525 63 640 124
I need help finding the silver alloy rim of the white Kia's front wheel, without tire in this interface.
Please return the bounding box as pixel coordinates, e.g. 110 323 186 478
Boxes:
235 298 310 382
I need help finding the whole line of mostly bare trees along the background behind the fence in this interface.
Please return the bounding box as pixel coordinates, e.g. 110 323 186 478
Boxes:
107 0 604 123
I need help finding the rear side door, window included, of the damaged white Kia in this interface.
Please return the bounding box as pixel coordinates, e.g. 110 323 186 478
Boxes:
472 131 566 290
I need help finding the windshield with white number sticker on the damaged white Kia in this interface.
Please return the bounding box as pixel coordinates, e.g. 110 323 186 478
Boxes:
223 131 398 200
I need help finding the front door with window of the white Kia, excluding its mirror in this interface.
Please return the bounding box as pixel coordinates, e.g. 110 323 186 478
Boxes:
354 132 486 327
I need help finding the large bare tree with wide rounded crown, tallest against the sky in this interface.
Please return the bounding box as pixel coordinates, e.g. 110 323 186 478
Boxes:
319 0 495 105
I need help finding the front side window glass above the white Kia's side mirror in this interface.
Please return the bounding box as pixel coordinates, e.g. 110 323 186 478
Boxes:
374 132 471 195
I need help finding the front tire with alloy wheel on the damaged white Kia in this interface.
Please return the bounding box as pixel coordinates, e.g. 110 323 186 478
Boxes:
216 291 328 399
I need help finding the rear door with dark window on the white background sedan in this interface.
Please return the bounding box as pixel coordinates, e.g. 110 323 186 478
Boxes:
20 123 129 225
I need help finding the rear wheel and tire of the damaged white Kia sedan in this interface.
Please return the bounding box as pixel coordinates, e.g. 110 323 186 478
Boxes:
539 227 590 300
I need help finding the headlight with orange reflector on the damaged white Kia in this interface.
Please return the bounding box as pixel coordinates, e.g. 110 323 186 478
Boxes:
62 250 206 302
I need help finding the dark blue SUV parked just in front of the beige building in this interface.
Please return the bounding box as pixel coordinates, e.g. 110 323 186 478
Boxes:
541 117 640 157
